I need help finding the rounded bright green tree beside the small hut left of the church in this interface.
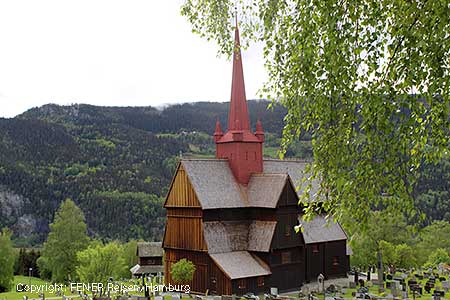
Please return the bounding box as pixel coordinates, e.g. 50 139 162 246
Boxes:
76 242 129 285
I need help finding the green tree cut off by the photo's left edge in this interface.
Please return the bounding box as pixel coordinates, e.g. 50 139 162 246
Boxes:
0 228 15 292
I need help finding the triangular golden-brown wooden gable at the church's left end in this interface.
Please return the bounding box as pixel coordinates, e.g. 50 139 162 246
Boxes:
164 163 201 208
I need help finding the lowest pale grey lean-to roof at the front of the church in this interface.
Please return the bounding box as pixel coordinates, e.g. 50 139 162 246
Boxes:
210 251 272 279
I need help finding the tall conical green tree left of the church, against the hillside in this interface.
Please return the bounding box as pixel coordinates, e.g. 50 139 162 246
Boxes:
38 199 89 282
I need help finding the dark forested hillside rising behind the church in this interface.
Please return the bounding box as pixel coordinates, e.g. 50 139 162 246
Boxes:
0 101 450 245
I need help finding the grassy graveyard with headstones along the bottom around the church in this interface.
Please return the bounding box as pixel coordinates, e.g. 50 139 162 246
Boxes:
0 264 450 300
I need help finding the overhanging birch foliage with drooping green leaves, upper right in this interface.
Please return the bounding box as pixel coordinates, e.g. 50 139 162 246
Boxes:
181 0 450 226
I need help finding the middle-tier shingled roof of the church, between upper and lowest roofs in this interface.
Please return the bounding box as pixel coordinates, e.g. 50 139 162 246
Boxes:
203 221 276 253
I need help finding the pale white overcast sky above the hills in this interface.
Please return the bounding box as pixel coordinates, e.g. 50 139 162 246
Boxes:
0 0 266 117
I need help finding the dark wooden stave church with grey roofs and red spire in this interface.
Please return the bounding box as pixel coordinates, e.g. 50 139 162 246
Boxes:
163 23 349 295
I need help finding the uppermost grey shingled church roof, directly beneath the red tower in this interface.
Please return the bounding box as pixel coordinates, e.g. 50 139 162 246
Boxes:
181 159 312 209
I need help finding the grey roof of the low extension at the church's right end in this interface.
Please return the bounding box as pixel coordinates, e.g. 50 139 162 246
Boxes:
298 215 347 244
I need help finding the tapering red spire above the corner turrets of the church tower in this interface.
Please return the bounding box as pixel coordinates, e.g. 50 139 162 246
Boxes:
228 19 250 130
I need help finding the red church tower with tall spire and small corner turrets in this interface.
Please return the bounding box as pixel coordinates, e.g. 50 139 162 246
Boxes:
214 23 264 185
